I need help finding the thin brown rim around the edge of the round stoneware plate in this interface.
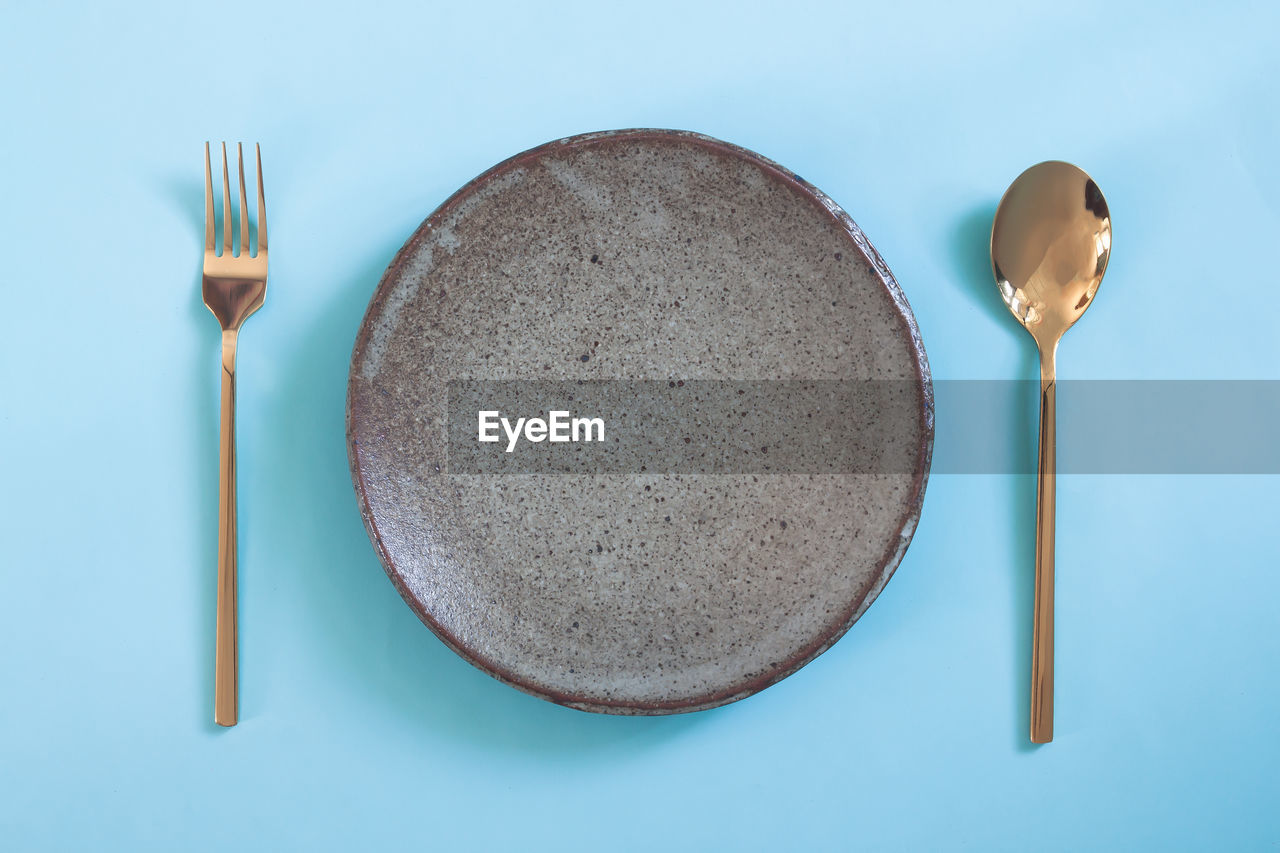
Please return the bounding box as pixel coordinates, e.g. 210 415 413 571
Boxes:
346 128 934 716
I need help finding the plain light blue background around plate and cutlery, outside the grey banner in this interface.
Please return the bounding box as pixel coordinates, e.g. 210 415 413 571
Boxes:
0 0 1280 850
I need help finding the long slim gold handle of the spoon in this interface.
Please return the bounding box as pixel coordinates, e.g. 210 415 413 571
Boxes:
1032 346 1057 743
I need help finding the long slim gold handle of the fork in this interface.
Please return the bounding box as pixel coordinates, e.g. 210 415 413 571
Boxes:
214 329 239 726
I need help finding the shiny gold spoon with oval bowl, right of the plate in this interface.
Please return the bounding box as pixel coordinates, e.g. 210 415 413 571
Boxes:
991 160 1111 743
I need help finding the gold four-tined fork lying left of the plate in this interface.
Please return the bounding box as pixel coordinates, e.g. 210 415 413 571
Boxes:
204 142 266 726
